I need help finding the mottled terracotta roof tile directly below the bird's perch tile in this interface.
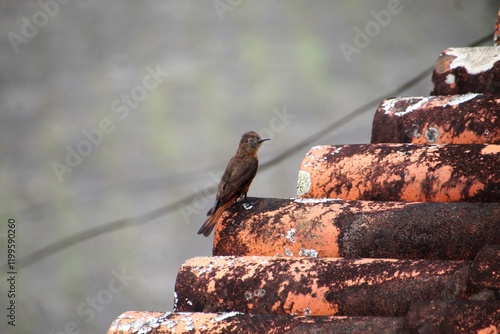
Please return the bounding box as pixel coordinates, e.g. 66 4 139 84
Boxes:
174 256 470 317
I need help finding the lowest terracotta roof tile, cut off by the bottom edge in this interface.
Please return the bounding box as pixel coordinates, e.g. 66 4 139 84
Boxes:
108 311 406 334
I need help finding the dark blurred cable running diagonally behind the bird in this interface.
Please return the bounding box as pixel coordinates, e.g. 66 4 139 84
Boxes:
2 34 492 270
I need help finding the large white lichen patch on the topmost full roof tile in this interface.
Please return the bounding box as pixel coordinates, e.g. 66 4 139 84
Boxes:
446 46 500 74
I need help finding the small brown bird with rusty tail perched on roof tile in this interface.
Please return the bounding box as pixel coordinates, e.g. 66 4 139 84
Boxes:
198 131 269 237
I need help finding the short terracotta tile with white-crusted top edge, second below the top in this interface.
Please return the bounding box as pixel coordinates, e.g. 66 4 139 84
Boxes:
371 93 500 144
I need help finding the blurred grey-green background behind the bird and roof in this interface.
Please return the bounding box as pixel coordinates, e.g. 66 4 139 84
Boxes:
0 0 499 334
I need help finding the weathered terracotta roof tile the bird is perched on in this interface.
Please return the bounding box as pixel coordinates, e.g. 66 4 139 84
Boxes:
213 198 500 260
